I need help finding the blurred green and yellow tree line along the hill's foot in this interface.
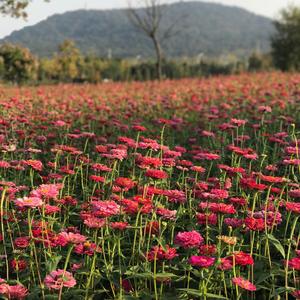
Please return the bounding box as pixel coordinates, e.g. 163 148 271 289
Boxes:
0 40 271 84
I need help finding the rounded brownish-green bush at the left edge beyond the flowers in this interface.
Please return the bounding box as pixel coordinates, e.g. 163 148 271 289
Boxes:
0 44 37 84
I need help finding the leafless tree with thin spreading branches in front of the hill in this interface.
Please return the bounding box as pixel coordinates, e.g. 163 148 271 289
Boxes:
127 0 182 80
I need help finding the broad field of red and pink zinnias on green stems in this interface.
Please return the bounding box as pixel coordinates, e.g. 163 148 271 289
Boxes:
0 73 300 300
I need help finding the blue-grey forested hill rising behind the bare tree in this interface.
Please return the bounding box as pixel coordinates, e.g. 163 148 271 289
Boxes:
0 2 273 57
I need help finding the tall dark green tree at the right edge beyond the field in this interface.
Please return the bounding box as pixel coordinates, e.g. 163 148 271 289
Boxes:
272 6 300 71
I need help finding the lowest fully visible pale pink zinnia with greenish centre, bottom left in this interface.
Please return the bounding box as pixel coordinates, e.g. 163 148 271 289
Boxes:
44 269 76 290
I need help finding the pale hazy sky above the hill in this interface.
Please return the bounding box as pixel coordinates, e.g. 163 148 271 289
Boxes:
0 0 300 38
